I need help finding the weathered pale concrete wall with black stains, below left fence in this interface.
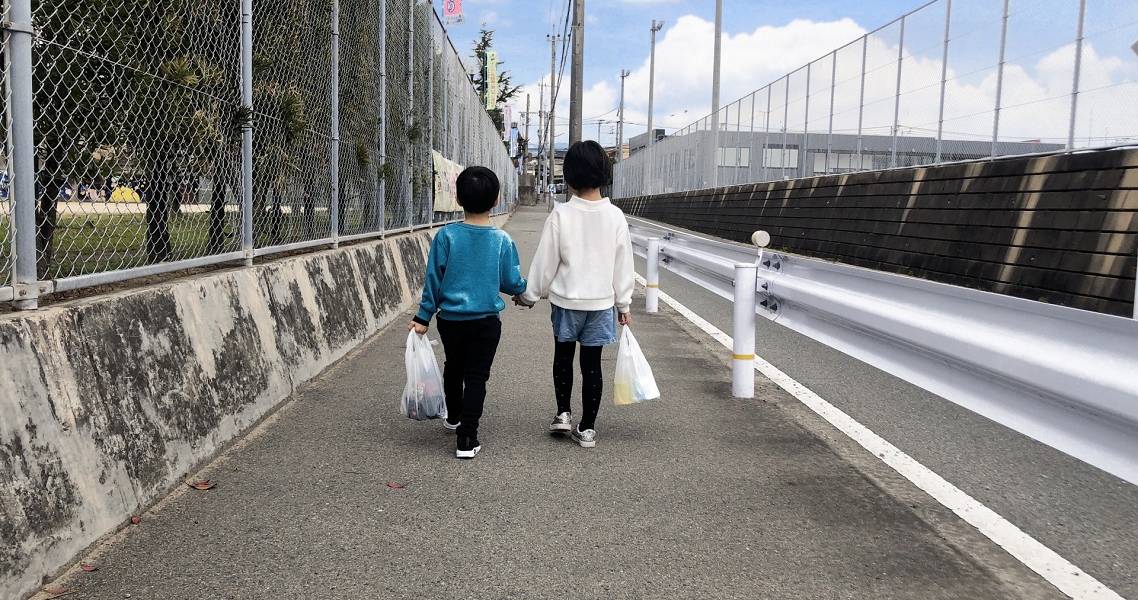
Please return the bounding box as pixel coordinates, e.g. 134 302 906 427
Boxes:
0 232 431 598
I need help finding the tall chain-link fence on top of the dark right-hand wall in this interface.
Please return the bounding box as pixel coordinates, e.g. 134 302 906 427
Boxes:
613 0 1138 197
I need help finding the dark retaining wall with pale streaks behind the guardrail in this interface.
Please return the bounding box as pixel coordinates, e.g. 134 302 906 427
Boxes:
616 149 1138 317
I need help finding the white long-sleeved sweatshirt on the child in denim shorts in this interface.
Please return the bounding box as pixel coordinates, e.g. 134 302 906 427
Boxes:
523 196 635 312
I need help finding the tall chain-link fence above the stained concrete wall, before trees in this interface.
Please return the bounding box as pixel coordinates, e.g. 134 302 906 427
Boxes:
0 0 517 307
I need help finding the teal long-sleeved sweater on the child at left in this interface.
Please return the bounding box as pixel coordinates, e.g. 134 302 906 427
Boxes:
414 223 526 324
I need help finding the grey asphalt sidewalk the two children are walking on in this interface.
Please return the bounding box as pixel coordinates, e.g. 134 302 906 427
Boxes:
42 208 1057 599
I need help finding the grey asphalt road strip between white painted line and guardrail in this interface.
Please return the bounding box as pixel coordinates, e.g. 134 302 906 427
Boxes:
636 236 1138 599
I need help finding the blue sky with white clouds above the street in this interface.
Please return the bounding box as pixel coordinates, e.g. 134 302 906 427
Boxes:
439 0 1138 149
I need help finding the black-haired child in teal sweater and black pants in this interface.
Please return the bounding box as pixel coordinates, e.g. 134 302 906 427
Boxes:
407 166 526 459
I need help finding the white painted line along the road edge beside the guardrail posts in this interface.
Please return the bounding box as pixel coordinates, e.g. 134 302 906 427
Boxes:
636 276 1124 600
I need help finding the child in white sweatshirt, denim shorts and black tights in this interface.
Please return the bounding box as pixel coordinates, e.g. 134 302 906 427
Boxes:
514 140 635 447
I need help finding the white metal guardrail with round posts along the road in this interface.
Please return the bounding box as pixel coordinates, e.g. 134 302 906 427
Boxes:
629 217 1138 484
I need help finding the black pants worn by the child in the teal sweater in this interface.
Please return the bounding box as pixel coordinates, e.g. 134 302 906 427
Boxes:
438 317 502 437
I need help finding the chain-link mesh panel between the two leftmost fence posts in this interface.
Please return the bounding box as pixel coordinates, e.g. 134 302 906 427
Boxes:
28 0 240 279
